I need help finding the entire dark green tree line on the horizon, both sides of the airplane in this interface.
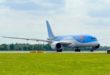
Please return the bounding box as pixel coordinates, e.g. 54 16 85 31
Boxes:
0 43 110 51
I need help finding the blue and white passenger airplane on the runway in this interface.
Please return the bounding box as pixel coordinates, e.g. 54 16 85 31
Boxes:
0 21 100 52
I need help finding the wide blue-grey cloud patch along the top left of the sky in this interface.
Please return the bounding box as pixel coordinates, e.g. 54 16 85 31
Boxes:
0 0 64 14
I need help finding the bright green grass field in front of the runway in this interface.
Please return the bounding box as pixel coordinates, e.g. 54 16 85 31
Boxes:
0 53 110 75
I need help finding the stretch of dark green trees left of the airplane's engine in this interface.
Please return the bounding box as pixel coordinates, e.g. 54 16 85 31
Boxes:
0 43 51 51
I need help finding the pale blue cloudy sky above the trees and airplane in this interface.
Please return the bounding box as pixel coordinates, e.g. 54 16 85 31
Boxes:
0 0 110 46
